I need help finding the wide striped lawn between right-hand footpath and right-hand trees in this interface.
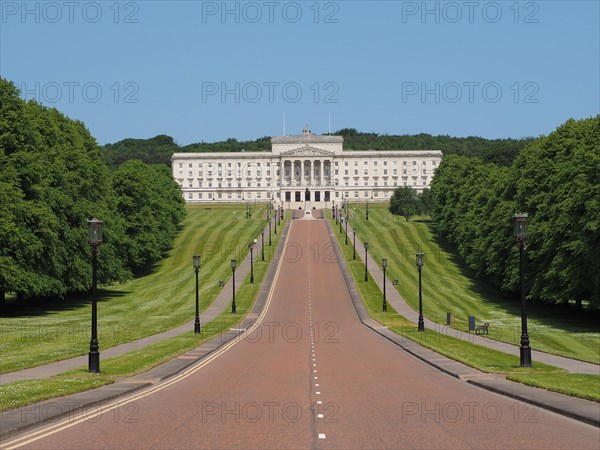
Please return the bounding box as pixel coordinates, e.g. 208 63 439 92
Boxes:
348 203 600 364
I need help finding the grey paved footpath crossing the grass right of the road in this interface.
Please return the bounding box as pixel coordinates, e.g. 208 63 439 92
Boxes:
342 225 600 375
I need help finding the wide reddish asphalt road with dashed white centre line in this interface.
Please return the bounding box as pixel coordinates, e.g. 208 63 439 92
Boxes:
10 220 600 449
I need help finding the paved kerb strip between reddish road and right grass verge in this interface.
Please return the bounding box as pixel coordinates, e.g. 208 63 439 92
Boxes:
326 221 600 428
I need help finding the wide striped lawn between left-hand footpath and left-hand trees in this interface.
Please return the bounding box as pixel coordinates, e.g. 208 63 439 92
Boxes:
0 205 275 373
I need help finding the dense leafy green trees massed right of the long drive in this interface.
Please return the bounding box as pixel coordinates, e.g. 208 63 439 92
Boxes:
431 116 600 308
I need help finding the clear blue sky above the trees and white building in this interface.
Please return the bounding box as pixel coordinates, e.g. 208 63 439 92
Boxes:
0 0 600 144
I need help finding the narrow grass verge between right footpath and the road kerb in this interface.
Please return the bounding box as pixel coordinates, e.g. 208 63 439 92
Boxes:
328 210 600 401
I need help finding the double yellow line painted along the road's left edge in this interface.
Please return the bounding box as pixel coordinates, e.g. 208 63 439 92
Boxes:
2 224 292 450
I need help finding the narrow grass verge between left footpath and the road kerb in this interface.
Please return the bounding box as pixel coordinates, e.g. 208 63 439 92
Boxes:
0 207 284 411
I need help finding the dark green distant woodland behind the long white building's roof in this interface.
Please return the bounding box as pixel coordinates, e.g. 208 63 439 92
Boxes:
103 128 533 167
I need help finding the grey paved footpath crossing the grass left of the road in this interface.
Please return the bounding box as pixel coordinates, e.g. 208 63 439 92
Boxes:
0 217 283 385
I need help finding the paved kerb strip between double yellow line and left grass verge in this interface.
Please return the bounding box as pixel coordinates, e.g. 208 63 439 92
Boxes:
0 220 292 442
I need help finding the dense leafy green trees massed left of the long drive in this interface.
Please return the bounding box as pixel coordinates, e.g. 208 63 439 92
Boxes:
0 78 185 303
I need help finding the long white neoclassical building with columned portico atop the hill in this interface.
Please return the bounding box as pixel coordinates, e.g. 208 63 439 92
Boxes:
172 126 442 209
